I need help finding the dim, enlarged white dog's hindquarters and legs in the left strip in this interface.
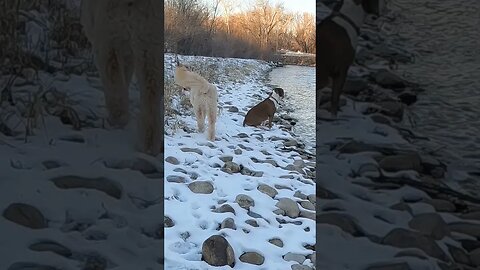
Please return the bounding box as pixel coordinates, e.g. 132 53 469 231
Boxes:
81 0 163 155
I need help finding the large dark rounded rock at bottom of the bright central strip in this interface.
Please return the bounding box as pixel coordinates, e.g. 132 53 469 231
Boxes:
202 235 235 267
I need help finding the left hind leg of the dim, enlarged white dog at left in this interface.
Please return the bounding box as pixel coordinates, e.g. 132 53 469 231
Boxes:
94 41 129 128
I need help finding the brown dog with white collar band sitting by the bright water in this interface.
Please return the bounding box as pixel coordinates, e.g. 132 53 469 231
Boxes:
243 88 285 128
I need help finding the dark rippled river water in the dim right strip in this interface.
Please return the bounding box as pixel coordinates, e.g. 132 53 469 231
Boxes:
386 0 480 190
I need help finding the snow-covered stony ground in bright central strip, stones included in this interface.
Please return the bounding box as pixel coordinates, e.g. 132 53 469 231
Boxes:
165 54 315 270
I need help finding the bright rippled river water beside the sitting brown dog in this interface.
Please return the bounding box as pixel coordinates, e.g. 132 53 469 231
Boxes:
270 65 315 150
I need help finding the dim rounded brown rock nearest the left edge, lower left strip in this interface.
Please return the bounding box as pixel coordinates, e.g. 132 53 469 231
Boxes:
3 203 48 229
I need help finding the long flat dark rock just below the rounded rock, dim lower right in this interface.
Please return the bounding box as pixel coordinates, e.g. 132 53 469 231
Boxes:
381 228 447 260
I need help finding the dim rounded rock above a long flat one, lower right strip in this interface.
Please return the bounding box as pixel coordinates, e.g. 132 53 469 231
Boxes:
408 213 450 240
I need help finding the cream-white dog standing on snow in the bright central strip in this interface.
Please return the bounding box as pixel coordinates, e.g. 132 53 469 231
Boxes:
175 59 218 141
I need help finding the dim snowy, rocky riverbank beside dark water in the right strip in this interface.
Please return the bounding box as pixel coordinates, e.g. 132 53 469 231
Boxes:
316 2 480 270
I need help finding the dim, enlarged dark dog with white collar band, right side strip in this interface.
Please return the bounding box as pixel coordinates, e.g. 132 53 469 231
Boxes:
317 0 384 116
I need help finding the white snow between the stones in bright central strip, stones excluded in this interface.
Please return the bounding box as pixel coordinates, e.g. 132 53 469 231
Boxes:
165 55 315 269
